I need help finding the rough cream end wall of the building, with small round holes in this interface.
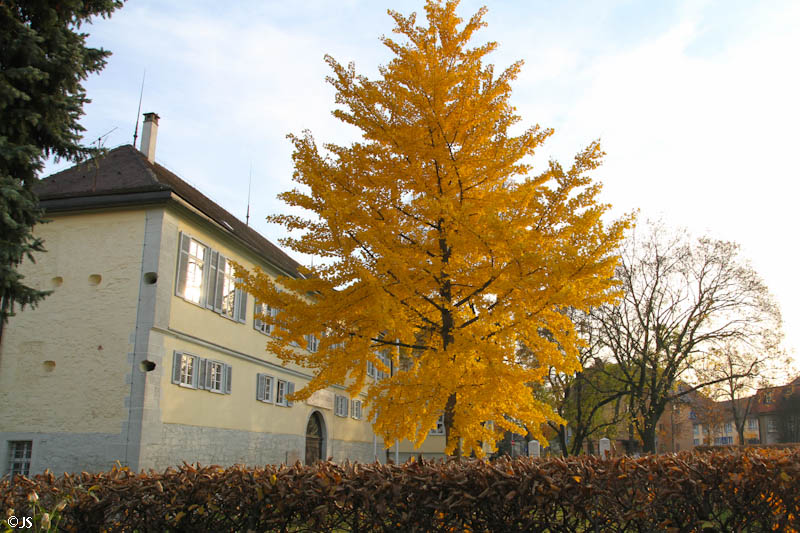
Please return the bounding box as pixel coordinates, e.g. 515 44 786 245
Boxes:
0 210 145 433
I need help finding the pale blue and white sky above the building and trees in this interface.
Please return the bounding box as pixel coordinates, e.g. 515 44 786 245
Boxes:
42 0 800 362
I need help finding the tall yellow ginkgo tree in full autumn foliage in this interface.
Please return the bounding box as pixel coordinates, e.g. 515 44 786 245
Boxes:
239 0 629 454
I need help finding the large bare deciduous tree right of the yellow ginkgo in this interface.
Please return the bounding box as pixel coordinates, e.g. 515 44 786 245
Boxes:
595 223 780 452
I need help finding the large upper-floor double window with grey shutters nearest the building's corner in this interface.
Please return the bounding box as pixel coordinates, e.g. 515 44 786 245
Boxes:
175 233 247 322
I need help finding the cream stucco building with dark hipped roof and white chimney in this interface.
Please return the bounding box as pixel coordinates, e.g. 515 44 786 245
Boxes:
0 114 444 475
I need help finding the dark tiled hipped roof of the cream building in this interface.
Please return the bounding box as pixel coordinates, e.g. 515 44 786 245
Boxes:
35 145 300 276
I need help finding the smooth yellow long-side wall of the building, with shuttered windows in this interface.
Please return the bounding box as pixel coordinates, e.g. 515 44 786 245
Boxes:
161 211 380 443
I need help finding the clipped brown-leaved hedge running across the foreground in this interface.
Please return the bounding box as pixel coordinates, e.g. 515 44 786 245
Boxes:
0 449 800 533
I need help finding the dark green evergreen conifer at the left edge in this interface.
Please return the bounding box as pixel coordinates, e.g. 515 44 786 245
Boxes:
0 0 122 341
